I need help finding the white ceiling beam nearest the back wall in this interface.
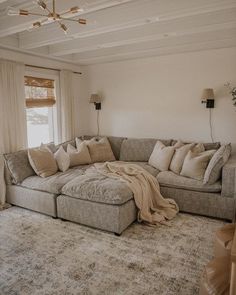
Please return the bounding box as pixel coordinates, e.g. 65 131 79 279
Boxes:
75 39 236 65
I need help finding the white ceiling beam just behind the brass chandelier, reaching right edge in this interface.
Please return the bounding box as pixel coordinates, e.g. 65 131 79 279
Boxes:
20 0 236 49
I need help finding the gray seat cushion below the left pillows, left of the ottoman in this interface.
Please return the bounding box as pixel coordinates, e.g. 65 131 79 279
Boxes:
20 165 91 194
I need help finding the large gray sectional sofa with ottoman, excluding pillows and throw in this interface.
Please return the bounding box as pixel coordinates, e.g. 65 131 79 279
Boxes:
5 137 236 234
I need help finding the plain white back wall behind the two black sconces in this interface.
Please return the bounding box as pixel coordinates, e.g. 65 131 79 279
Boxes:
87 48 236 151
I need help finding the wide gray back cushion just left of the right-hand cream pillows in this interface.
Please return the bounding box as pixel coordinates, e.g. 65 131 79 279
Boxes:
120 138 171 162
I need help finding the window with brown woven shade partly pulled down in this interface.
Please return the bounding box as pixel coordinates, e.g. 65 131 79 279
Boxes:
25 76 56 147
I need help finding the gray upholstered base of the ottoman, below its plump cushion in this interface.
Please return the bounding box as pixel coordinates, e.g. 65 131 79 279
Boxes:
57 195 137 234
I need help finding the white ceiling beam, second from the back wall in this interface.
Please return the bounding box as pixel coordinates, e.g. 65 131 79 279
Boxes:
49 8 236 56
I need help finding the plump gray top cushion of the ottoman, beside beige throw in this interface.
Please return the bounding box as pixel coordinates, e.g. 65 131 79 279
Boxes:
62 168 133 205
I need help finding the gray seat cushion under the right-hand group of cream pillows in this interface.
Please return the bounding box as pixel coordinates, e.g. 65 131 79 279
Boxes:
157 171 221 193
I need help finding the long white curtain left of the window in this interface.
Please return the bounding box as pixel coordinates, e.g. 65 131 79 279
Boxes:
0 59 27 208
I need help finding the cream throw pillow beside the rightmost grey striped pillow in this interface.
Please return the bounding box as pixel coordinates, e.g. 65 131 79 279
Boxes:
180 150 216 180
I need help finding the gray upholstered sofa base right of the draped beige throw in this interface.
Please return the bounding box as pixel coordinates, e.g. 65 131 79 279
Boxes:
161 186 236 221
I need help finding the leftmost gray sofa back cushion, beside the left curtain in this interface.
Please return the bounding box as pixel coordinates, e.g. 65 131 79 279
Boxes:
4 150 35 184
